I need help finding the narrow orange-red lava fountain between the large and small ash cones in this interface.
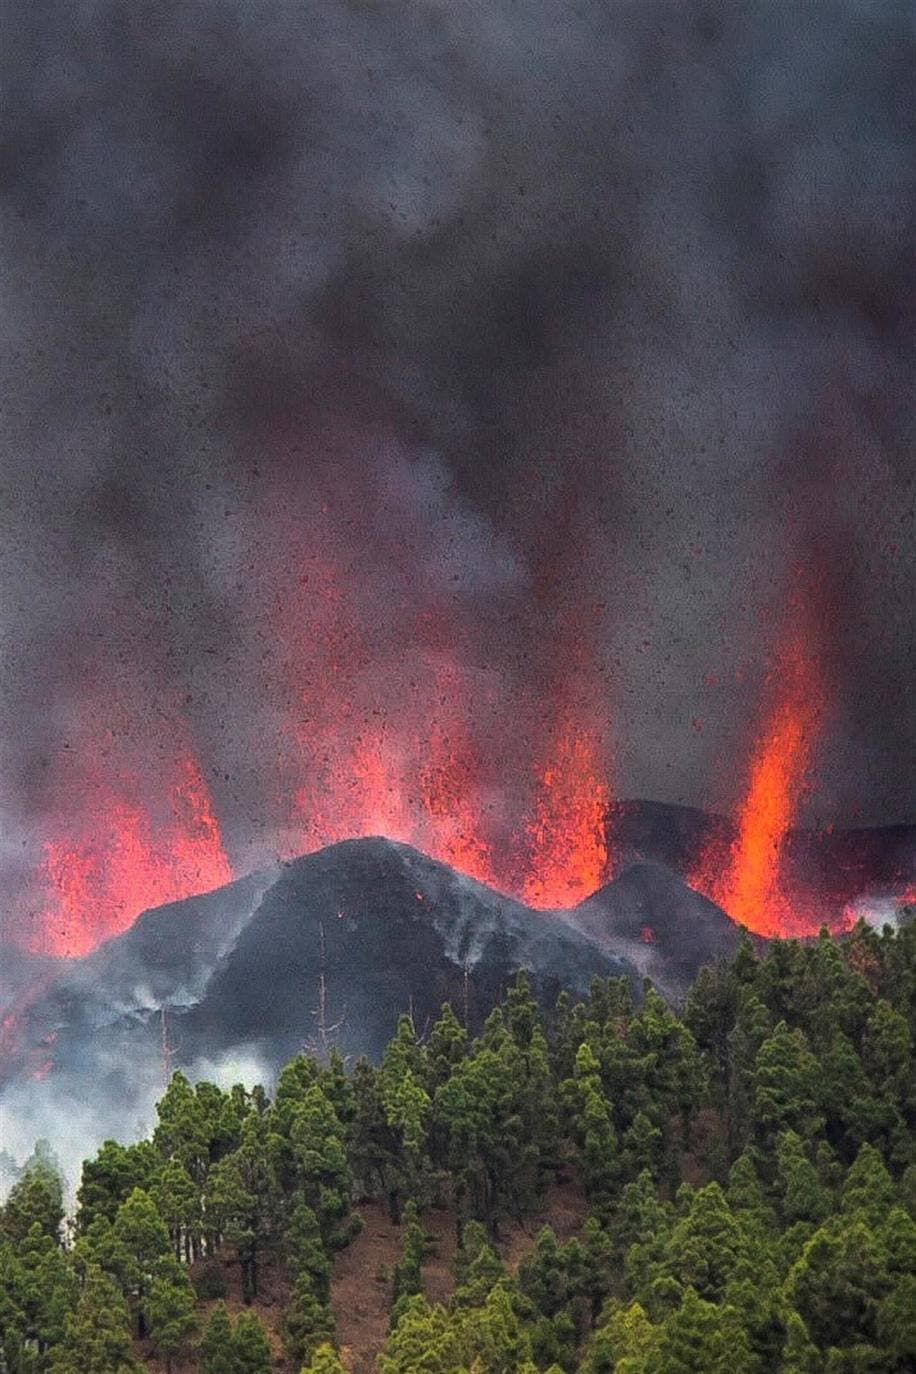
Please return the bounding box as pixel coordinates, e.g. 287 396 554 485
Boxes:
522 721 610 910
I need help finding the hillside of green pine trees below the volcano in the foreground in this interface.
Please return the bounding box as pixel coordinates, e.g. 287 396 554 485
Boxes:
0 912 916 1374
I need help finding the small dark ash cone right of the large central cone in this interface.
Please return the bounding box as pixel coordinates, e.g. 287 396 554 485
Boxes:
566 863 742 998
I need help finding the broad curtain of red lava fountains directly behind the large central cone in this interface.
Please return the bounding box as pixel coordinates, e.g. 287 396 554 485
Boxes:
277 558 608 908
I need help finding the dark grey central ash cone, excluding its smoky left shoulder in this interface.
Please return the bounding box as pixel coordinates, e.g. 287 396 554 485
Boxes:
180 838 634 1063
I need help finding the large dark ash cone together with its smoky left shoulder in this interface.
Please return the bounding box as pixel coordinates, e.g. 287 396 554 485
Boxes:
0 840 637 1095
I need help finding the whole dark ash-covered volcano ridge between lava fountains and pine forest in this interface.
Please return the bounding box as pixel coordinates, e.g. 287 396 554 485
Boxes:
0 802 916 1187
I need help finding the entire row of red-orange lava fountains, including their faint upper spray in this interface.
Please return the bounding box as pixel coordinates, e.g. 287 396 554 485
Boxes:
3 522 912 956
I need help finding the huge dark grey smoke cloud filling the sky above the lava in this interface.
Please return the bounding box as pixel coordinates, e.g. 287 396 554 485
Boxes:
0 0 916 934
